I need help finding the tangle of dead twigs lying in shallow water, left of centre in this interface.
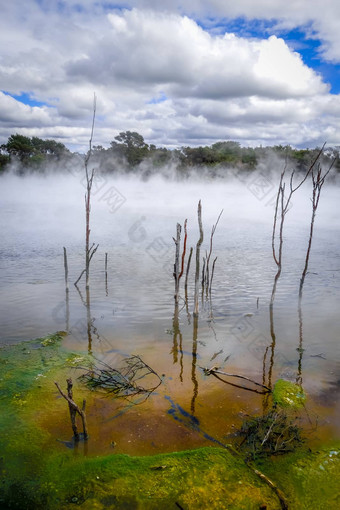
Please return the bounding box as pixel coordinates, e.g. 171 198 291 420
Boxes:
80 356 162 400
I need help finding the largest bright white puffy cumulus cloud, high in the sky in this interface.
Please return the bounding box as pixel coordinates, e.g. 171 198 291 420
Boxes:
66 9 327 98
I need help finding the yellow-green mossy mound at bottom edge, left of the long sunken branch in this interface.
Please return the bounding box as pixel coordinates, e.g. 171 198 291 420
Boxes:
41 448 280 510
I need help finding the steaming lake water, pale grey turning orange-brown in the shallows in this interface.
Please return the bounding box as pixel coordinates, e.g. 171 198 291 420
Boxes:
0 175 340 454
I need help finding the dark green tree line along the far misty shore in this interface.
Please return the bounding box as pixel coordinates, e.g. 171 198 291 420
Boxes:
0 131 340 175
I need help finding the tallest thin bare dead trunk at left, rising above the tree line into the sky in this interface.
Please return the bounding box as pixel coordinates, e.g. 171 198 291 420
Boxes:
75 95 99 287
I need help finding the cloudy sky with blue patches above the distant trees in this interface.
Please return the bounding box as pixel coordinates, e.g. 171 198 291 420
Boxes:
0 0 340 152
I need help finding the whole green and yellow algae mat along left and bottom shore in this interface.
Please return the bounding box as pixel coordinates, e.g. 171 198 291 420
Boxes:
0 334 340 510
